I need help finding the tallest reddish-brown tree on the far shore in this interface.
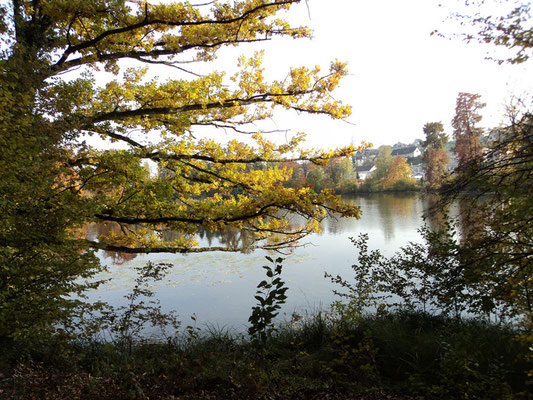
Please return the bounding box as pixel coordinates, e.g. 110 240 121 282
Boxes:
452 92 485 168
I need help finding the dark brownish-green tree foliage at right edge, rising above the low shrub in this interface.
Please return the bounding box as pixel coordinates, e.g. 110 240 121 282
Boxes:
446 112 533 318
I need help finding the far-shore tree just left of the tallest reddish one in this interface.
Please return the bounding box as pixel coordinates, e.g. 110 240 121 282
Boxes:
422 122 449 189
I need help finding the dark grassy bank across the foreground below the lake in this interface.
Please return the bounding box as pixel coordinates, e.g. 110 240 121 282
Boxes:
0 312 531 400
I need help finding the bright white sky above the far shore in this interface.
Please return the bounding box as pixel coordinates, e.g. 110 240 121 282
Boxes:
202 0 533 148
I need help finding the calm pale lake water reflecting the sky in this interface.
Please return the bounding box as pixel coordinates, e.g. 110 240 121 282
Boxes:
89 193 444 331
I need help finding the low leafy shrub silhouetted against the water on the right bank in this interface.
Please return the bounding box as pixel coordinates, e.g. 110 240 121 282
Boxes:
334 209 531 321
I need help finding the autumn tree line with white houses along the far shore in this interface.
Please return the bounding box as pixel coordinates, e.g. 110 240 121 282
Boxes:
236 93 490 194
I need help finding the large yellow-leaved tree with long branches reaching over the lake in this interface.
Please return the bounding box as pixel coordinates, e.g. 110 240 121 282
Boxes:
0 0 358 339
